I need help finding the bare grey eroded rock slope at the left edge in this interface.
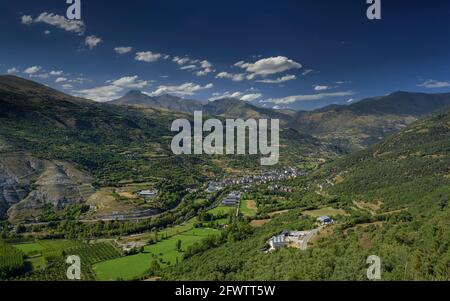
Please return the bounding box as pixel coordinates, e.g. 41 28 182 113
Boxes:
0 147 94 222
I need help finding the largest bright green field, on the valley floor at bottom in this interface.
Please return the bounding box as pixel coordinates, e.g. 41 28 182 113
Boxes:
93 228 218 281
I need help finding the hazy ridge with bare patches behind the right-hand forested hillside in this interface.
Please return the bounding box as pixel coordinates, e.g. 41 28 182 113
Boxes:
290 91 450 150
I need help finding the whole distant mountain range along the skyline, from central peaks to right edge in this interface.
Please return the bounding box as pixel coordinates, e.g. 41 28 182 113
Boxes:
111 86 450 151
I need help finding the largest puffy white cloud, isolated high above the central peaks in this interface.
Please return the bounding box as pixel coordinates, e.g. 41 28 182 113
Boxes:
234 56 302 79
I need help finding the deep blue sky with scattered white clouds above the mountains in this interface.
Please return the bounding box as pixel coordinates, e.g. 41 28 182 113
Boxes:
0 0 450 109
